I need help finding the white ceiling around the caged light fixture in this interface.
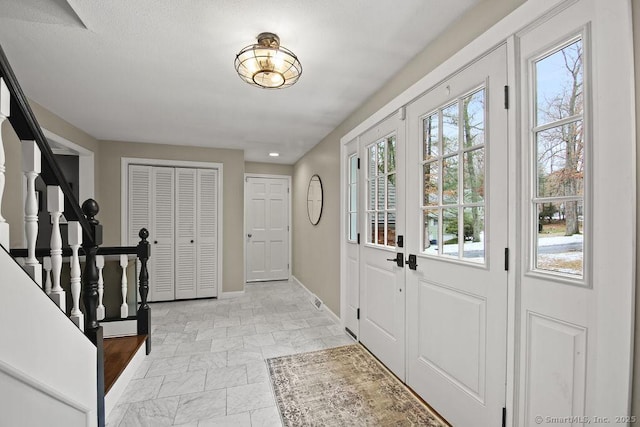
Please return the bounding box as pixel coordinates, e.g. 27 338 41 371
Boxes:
0 0 479 164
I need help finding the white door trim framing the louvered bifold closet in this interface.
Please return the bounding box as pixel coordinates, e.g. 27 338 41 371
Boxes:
120 157 224 296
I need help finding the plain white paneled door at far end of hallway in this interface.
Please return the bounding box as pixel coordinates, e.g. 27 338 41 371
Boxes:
245 176 290 282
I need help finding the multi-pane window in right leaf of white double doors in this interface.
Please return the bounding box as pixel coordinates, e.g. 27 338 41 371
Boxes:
422 88 486 263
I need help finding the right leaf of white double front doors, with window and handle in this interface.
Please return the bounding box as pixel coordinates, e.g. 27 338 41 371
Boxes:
406 45 508 426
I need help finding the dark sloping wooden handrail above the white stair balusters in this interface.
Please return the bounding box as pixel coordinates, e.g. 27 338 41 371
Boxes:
0 45 93 242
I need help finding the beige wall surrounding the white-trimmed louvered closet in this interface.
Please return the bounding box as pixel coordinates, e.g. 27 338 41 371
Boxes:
96 141 244 292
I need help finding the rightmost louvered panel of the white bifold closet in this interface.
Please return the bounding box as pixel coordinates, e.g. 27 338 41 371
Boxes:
196 169 218 298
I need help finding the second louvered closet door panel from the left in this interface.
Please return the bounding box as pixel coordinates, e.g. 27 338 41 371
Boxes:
150 167 175 301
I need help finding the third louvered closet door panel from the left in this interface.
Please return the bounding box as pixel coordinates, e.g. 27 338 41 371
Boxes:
176 169 199 299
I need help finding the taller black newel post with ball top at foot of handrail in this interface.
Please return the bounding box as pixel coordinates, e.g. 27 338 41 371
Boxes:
82 199 105 427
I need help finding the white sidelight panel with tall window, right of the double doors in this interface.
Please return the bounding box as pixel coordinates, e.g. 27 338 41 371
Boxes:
516 0 638 426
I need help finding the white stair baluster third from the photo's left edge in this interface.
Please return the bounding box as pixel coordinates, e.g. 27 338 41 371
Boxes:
47 185 67 313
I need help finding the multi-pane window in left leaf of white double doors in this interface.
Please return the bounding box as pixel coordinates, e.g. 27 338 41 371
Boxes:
367 134 397 247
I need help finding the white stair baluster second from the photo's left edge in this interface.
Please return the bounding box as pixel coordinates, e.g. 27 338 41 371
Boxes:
22 141 42 286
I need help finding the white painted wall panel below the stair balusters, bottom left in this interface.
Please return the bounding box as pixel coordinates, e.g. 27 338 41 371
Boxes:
0 250 97 427
